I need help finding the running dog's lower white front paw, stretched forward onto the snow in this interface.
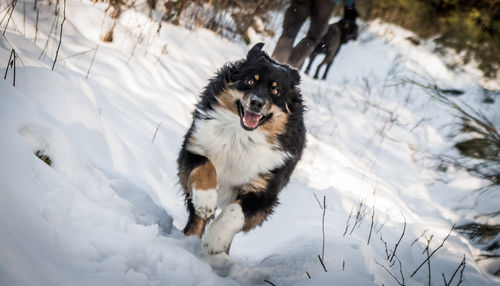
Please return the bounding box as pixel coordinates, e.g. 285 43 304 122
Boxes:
201 204 245 255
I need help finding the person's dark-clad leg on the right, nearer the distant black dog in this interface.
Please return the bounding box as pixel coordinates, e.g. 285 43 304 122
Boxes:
288 0 335 67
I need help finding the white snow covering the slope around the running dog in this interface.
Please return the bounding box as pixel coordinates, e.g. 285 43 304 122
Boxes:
0 0 500 285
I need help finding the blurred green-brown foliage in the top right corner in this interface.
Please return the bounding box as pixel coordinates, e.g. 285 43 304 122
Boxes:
356 0 500 78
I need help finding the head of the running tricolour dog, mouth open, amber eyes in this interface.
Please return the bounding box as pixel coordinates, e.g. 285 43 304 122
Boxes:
218 43 302 131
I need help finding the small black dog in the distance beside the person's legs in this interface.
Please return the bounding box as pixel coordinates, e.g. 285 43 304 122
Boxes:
305 20 358 80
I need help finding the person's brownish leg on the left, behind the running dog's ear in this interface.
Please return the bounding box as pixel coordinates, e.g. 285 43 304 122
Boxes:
272 0 311 63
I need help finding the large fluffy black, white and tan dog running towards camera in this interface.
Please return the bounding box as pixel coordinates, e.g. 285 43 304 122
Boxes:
177 43 305 254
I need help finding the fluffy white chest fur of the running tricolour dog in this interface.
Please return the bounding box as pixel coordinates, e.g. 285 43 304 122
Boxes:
188 109 289 189
